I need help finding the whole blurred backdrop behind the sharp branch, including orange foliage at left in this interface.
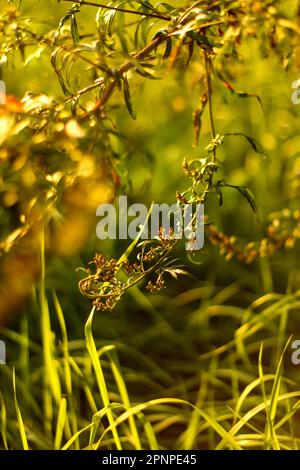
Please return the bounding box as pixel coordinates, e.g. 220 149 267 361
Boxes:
0 0 300 448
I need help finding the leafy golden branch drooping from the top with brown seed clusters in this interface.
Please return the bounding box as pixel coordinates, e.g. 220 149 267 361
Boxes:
0 4 299 308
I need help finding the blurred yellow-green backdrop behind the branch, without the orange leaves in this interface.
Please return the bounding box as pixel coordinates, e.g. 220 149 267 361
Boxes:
0 0 300 448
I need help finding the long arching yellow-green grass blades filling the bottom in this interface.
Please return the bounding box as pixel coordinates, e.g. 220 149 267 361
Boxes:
0 241 300 450
